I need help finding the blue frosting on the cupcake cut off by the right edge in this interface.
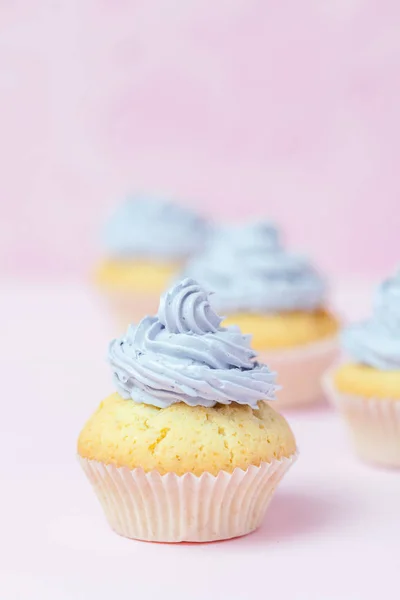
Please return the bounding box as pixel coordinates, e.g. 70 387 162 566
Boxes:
342 271 400 371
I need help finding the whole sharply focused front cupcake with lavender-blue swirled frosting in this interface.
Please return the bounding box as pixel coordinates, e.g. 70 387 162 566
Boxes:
78 279 296 542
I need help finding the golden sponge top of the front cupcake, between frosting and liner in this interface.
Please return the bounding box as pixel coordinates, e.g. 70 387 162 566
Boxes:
78 393 296 475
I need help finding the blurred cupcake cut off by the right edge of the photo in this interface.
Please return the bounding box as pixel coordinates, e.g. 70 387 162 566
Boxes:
325 272 400 467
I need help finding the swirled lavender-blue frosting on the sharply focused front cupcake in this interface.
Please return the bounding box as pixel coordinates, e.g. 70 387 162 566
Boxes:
109 279 278 408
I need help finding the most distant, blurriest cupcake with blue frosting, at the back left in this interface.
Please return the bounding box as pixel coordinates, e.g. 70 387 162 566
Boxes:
96 196 208 327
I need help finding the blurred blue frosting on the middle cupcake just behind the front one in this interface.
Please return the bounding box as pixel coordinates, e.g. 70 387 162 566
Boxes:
184 222 326 314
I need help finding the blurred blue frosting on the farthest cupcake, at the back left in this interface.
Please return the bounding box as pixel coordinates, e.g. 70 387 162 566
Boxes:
104 196 208 260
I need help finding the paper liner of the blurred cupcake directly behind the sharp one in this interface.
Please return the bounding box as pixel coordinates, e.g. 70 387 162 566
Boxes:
258 336 338 410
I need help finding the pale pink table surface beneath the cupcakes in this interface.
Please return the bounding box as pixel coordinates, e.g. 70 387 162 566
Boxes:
0 282 400 600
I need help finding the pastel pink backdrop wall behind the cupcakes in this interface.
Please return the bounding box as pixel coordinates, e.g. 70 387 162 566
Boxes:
0 0 400 276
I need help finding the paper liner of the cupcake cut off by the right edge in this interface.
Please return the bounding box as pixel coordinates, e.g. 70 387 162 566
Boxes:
323 370 400 468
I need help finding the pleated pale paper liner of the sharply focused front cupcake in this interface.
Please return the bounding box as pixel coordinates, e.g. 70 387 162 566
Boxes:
79 455 296 542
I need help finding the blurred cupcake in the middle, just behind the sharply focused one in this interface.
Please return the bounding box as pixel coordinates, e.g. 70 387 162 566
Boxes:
184 222 338 407
